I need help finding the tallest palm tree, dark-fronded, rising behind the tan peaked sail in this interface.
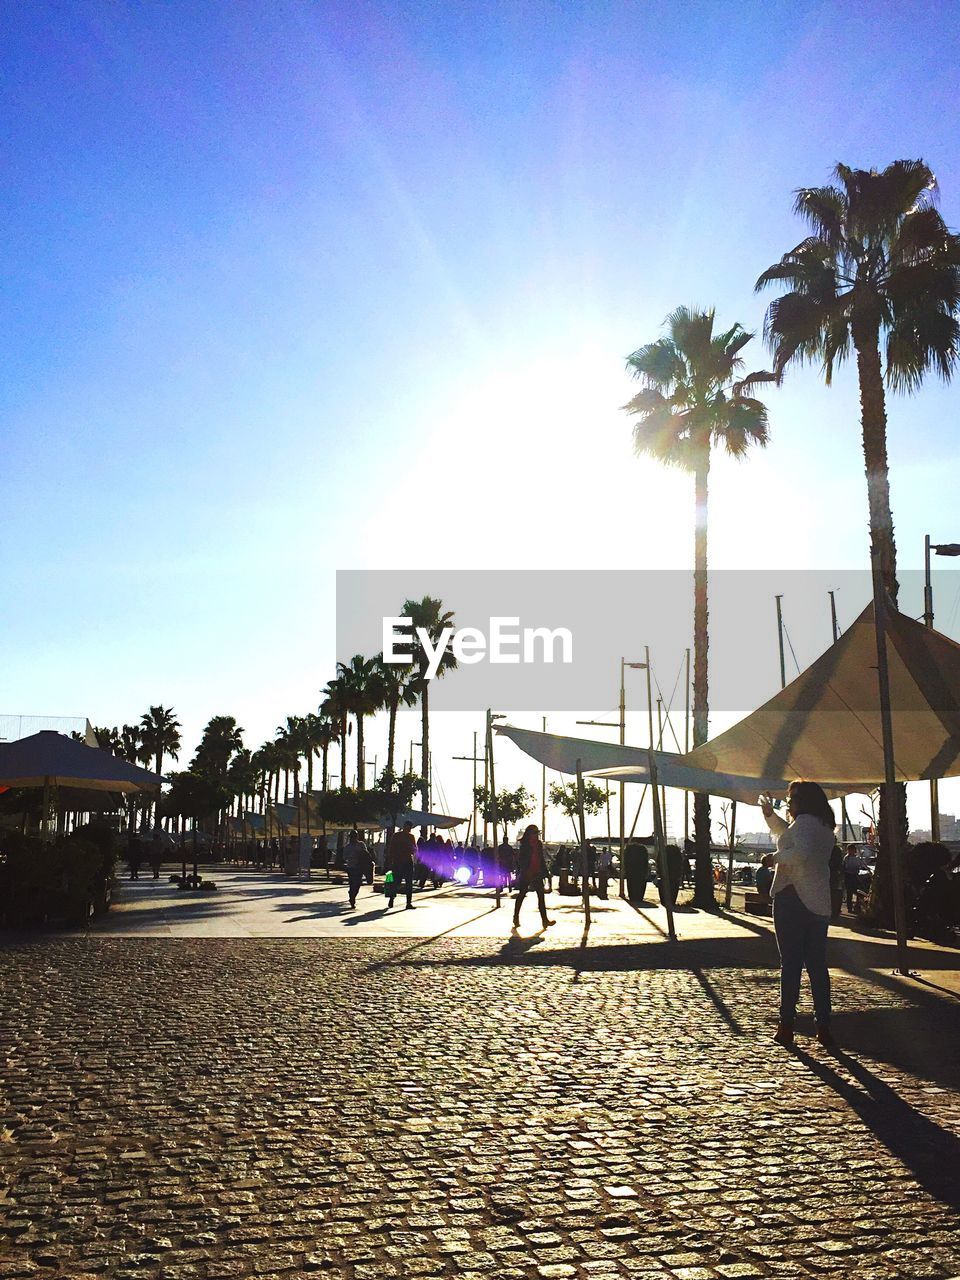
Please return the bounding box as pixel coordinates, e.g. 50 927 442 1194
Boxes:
756 160 960 918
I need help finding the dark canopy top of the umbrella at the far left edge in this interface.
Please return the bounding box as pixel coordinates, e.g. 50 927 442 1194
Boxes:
0 730 163 794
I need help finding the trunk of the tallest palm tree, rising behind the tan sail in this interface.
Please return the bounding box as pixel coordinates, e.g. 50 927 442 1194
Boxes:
854 329 908 925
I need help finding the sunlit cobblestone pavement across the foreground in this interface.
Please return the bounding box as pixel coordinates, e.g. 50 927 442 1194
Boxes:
0 934 960 1280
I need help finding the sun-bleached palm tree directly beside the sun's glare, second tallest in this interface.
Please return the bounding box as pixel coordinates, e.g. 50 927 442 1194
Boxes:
623 307 768 910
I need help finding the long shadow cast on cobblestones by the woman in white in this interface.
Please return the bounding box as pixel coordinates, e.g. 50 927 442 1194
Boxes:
792 1048 960 1208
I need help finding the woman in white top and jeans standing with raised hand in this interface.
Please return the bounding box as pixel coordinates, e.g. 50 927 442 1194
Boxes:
760 782 836 1046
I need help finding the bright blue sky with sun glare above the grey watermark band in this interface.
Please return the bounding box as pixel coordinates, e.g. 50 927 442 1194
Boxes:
0 0 960 829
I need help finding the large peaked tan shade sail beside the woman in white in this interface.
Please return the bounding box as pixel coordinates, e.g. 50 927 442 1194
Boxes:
684 604 960 791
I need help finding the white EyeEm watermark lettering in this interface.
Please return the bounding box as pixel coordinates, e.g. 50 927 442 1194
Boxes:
383 617 573 680
